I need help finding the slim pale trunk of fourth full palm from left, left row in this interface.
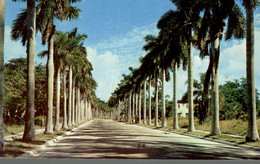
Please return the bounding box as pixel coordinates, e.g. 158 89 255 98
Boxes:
63 69 68 129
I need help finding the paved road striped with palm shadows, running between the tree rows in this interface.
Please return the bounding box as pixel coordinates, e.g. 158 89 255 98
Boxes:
33 120 260 159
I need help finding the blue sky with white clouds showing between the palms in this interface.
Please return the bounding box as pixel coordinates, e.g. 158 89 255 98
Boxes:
5 0 260 101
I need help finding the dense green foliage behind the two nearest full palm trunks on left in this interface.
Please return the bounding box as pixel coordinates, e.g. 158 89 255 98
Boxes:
4 58 47 124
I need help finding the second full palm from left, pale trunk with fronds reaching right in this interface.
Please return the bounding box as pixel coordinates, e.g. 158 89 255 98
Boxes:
39 0 79 133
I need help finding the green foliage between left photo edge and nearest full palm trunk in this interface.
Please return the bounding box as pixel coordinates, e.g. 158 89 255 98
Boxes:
4 58 26 123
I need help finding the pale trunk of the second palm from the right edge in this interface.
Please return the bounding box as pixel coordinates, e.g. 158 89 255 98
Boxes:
210 38 221 135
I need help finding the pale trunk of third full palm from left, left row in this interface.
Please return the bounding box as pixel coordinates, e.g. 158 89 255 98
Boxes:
54 68 60 131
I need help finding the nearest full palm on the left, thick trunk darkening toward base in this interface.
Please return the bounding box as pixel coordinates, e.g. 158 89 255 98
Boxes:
12 0 36 141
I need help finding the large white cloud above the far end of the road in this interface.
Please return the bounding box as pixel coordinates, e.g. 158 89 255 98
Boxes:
87 47 121 101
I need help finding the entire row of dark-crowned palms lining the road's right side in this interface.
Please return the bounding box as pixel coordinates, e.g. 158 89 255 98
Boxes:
109 0 259 141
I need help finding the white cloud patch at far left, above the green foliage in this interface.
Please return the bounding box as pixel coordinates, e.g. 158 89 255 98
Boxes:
4 26 26 63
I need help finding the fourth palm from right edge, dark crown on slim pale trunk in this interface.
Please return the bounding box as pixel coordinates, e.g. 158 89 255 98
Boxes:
157 10 187 129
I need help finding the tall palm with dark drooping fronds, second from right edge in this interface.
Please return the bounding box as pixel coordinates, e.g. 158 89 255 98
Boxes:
197 0 245 135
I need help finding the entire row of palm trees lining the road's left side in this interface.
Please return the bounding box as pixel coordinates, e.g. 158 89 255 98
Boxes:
0 0 103 152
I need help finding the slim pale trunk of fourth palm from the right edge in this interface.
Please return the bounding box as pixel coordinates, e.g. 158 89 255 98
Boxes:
173 62 179 129
